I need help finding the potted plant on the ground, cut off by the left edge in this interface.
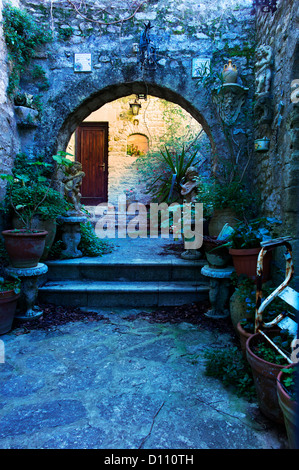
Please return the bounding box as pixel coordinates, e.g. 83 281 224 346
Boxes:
0 277 21 335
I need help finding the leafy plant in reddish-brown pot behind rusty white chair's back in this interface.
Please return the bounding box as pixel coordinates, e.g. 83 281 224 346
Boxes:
228 217 281 282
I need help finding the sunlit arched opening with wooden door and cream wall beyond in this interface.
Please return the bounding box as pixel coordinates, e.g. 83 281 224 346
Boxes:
66 95 211 206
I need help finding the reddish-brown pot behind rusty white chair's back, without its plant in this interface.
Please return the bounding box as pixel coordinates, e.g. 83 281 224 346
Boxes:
229 248 272 282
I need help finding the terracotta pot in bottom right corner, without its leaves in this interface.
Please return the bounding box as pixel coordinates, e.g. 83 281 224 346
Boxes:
277 364 299 449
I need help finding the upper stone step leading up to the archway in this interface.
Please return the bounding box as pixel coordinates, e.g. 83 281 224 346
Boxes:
47 257 206 283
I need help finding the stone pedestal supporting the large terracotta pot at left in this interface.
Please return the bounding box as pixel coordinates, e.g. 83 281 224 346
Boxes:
5 263 48 321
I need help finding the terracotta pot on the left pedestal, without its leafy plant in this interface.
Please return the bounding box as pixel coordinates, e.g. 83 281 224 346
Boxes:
2 230 48 268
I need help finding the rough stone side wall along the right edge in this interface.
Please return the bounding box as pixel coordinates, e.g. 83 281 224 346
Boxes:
255 0 299 278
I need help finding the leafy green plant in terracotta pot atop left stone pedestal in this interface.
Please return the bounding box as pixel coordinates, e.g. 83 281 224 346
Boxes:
0 155 67 268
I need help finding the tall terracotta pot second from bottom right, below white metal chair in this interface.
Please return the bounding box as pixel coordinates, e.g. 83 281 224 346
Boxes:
246 333 286 424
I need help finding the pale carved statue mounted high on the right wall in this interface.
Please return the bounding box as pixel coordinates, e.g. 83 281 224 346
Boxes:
255 45 272 95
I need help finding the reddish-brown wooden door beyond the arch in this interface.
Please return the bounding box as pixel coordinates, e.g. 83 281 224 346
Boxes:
75 122 108 205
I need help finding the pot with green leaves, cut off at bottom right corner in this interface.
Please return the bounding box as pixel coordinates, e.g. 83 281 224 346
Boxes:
277 364 298 449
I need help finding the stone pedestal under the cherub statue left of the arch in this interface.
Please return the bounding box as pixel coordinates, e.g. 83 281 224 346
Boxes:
59 215 87 258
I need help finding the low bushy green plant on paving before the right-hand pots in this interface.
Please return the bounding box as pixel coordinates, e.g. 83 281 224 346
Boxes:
204 346 255 399
